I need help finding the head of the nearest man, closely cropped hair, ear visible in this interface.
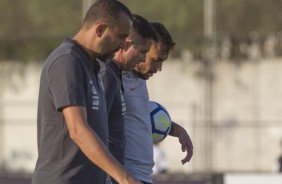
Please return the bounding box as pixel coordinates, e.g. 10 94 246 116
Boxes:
75 0 132 60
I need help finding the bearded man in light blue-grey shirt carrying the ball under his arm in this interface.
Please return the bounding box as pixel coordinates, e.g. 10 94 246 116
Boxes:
123 23 193 184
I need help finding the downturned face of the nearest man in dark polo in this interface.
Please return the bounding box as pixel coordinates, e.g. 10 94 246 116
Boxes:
100 12 132 59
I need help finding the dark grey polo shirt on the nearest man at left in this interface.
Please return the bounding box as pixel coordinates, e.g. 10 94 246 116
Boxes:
32 39 108 184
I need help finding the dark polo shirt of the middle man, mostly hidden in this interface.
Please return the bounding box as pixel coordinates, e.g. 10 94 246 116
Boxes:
99 61 126 164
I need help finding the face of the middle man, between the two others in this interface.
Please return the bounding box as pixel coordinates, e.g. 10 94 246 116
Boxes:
123 31 152 71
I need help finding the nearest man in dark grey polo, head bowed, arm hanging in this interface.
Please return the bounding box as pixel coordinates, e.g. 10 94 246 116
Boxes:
32 0 141 184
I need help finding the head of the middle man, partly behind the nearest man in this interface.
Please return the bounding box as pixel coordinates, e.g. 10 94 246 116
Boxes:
114 15 157 71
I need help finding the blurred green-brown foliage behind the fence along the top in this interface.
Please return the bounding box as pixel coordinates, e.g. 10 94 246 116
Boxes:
0 0 282 61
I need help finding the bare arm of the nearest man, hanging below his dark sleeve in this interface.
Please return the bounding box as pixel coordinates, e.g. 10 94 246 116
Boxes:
63 106 139 184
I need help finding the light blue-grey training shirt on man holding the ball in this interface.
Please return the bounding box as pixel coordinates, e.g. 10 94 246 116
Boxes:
122 72 154 183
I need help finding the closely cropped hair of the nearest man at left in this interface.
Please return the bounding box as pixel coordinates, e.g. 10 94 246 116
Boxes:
83 0 132 27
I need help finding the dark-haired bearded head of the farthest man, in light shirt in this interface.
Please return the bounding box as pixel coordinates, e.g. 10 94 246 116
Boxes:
134 22 175 80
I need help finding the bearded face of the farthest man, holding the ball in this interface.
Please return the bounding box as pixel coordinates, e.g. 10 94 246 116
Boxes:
134 43 169 80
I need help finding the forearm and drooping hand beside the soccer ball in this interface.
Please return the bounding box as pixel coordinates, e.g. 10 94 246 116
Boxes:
169 121 193 164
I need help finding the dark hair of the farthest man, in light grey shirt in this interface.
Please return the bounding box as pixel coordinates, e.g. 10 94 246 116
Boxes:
151 22 175 50
